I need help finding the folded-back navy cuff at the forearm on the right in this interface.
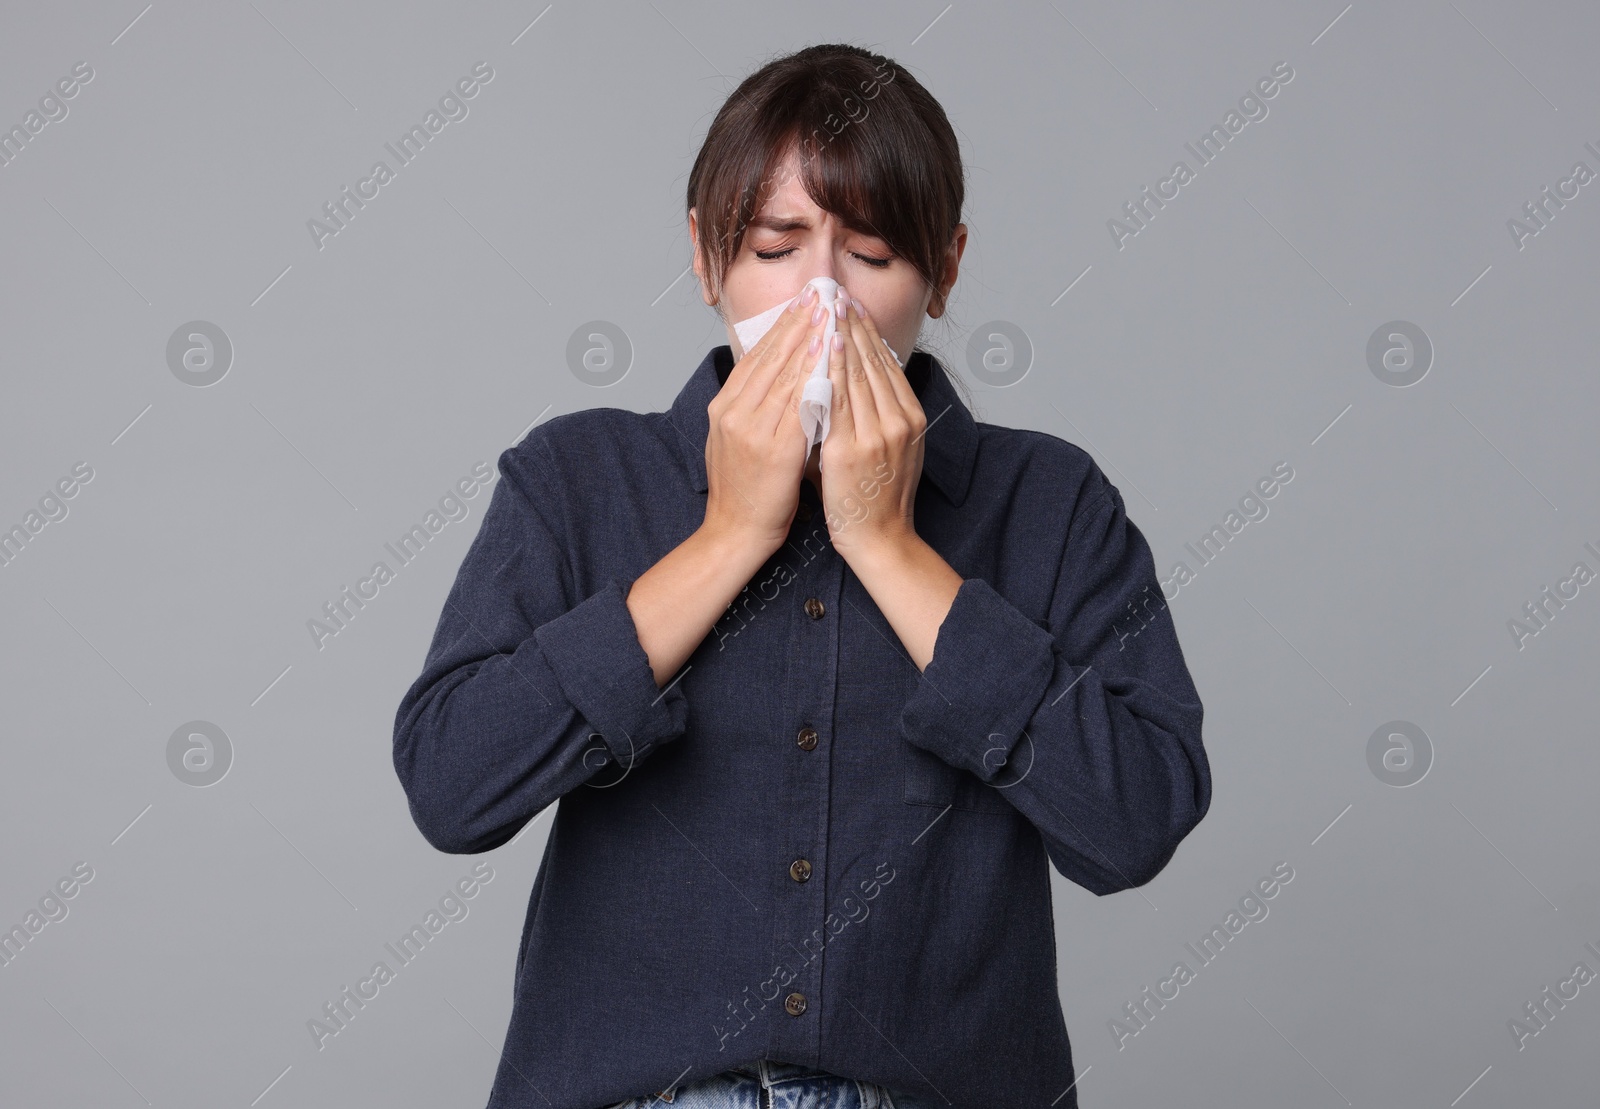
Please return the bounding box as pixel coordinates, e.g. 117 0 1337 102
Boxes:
901 578 1056 783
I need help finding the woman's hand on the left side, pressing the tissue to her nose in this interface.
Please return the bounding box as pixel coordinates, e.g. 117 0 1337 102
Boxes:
706 286 826 554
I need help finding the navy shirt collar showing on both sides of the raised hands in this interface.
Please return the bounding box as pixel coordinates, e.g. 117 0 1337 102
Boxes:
667 344 978 504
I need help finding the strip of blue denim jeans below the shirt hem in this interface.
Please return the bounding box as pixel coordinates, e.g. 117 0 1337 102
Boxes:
606 1059 942 1109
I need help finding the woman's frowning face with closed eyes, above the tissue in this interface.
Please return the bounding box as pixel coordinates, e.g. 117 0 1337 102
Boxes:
690 154 966 360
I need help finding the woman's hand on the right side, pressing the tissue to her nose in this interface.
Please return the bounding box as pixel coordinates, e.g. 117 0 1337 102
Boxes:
819 291 928 562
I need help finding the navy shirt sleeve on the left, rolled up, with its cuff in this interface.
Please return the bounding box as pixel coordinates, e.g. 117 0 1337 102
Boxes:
394 429 688 855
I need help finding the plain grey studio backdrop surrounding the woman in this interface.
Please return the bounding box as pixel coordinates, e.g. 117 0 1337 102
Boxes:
0 0 1600 1109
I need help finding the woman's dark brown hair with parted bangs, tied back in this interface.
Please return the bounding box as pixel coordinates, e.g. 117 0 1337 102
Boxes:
688 43 965 337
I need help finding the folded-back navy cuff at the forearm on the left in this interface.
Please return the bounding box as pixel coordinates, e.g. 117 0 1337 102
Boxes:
533 578 688 768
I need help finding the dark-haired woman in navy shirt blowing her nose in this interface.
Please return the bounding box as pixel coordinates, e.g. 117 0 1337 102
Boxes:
394 45 1211 1109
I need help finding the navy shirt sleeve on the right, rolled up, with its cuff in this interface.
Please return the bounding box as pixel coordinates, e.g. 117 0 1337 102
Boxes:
901 472 1211 895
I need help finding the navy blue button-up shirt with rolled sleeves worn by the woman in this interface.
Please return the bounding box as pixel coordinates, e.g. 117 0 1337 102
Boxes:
394 346 1211 1109
